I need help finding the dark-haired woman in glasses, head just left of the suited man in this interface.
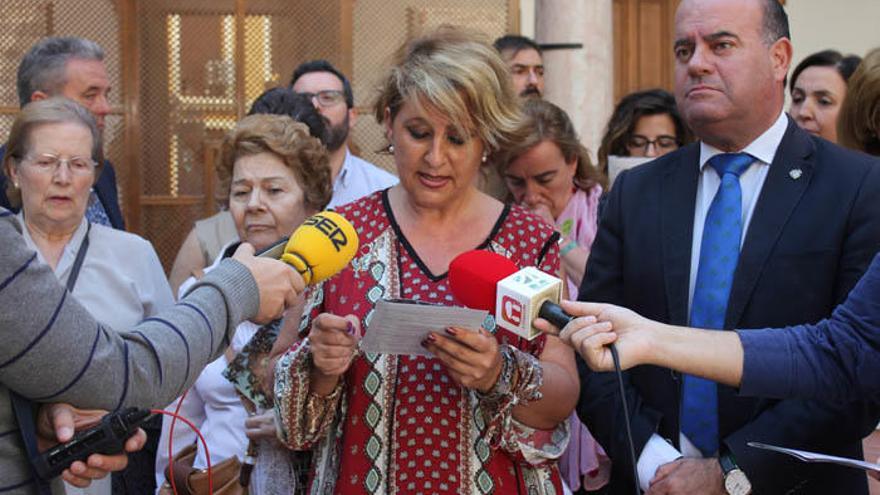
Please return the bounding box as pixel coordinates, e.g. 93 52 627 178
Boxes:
598 89 692 183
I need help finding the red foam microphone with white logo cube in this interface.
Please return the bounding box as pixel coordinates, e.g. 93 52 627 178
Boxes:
449 250 572 340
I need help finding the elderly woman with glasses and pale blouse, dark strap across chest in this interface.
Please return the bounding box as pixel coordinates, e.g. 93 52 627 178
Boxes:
3 98 174 493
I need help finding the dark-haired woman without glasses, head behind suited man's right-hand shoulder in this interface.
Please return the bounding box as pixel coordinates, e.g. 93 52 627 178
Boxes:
788 50 861 143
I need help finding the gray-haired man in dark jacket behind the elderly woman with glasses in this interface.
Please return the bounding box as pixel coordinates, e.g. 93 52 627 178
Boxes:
0 37 125 229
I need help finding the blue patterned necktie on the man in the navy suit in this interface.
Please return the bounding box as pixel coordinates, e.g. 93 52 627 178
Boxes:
681 153 755 456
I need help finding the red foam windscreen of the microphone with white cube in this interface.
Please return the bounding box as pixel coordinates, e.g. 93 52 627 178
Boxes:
449 250 519 314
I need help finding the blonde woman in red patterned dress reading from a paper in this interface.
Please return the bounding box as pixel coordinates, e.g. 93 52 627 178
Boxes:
275 28 579 494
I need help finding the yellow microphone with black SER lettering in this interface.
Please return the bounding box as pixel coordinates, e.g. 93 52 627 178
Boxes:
259 211 360 284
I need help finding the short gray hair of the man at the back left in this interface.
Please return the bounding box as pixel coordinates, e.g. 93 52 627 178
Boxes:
17 36 104 107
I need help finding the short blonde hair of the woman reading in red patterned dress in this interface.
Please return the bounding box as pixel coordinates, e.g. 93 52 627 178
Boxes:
374 26 522 157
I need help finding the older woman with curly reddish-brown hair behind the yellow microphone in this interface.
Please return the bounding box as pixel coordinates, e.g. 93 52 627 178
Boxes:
156 113 332 494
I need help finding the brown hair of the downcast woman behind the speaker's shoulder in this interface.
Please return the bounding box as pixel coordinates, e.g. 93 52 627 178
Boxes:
495 98 608 190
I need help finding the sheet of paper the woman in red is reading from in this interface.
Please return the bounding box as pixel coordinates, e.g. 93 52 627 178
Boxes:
360 300 488 356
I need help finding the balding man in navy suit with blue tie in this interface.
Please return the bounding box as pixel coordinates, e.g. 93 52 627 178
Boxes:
578 0 880 494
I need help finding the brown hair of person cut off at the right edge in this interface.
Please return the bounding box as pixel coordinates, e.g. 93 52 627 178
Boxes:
837 48 880 156
